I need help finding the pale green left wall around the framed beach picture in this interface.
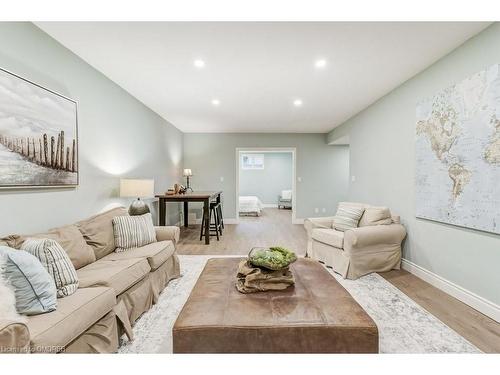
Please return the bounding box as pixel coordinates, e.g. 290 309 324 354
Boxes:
0 22 183 235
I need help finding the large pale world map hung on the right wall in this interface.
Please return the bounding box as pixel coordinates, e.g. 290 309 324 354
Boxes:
415 65 500 233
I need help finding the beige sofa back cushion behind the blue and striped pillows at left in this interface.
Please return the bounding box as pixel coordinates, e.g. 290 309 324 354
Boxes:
2 225 96 269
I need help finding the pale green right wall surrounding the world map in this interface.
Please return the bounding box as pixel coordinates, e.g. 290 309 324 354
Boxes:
328 23 500 304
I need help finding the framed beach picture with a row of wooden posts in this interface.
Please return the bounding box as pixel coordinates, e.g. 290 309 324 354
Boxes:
0 68 79 188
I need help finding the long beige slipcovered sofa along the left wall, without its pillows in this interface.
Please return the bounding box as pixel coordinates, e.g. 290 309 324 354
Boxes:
0 207 180 353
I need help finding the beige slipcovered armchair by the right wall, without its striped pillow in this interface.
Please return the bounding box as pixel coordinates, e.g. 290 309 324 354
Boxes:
304 202 406 279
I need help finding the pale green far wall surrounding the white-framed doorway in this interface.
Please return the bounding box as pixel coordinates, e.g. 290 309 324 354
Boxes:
183 133 349 219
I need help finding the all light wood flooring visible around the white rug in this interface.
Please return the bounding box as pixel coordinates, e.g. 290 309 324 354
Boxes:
177 208 500 353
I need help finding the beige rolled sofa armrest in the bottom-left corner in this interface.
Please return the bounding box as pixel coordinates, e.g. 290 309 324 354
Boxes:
0 319 30 353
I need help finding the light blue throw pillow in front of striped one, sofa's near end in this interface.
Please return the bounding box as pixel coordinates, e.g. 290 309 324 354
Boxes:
0 246 57 315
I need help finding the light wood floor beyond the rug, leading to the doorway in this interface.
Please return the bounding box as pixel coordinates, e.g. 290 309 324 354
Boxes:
177 208 306 256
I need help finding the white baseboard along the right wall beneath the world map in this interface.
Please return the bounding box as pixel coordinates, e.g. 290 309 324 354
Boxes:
401 259 500 323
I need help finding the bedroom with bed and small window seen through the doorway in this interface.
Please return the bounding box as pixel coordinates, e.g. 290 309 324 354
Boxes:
236 148 295 221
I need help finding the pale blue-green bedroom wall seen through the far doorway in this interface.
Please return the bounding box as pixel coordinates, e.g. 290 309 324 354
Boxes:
240 152 293 205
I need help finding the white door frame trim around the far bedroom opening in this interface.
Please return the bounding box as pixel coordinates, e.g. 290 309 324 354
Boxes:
235 147 297 224
